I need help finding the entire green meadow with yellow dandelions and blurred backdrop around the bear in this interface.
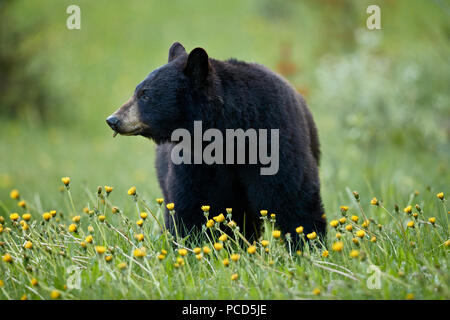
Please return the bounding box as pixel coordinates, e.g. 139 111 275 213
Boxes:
0 0 450 299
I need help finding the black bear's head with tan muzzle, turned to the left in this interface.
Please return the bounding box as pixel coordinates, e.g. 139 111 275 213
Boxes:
106 42 217 143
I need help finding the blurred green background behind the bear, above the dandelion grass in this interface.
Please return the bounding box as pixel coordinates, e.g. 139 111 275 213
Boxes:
0 0 450 215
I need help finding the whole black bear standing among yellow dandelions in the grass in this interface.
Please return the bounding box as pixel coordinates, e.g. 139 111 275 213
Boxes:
107 42 326 239
